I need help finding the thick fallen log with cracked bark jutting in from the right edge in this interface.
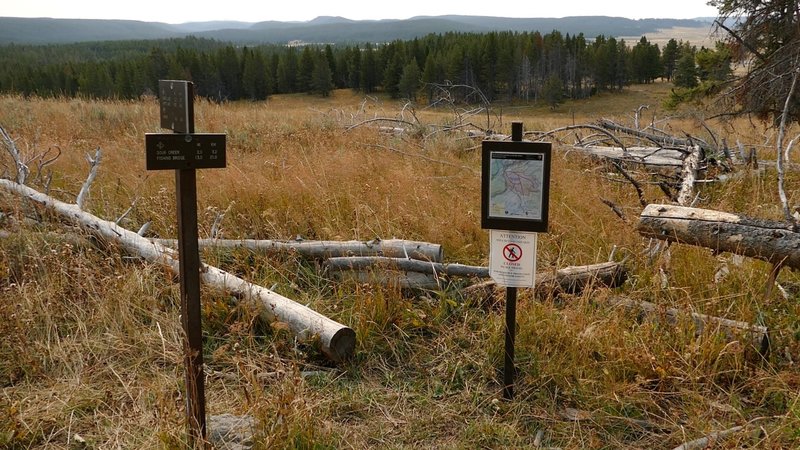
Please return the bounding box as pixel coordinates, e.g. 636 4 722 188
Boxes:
636 204 800 269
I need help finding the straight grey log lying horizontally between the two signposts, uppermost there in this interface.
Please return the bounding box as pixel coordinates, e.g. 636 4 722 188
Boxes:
153 239 443 262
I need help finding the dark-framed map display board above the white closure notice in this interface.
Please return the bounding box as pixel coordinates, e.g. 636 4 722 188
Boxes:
481 141 551 232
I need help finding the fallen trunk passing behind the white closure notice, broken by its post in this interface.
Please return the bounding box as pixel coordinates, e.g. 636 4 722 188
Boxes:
325 257 627 293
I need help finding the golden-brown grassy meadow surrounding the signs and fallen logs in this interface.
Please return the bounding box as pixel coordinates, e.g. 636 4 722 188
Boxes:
0 83 800 449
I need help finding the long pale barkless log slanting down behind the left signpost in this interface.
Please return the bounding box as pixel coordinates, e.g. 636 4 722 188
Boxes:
0 179 355 361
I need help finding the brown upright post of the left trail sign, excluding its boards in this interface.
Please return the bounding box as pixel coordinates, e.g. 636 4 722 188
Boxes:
175 83 206 449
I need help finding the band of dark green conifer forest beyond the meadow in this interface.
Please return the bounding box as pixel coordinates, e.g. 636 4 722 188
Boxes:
0 31 730 106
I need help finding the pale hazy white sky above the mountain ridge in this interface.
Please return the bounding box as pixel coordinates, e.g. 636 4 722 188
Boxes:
0 0 717 23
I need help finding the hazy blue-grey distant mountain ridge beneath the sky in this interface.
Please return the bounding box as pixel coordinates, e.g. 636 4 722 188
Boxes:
0 15 709 44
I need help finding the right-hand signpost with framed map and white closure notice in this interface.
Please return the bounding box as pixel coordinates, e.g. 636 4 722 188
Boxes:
481 122 551 400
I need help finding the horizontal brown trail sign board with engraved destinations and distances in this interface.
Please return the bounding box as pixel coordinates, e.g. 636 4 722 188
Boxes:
145 133 225 170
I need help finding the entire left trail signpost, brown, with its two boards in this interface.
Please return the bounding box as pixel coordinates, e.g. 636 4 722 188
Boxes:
145 80 225 448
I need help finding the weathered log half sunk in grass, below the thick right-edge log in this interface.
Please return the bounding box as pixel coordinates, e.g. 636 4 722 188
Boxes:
606 297 769 354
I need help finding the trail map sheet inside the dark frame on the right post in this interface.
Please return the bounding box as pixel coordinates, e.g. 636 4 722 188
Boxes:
489 152 544 220
